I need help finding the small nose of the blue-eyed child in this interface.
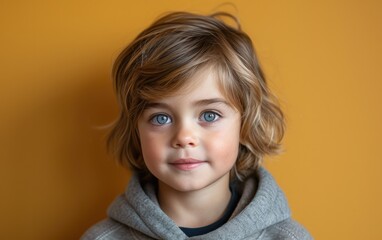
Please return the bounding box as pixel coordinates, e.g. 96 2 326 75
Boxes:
172 123 199 148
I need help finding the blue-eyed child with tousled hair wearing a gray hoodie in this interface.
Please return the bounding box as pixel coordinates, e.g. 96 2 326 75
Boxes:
82 12 311 239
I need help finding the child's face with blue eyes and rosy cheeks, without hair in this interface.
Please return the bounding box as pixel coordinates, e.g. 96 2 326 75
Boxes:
138 68 241 192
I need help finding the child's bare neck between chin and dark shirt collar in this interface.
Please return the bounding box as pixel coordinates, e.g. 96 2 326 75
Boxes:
158 176 231 228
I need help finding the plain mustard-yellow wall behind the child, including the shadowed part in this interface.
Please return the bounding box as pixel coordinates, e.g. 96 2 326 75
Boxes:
0 0 382 239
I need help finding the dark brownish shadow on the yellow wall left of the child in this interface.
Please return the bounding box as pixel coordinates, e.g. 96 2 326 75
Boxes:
3 69 129 239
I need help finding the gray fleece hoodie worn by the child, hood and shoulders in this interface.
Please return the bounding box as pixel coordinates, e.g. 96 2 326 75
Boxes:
81 168 312 240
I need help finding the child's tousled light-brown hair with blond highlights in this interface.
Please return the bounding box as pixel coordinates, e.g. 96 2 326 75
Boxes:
109 12 284 180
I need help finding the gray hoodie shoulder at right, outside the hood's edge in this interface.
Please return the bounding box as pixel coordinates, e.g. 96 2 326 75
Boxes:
260 218 313 240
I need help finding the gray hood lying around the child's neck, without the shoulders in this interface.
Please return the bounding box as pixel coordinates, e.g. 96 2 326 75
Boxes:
108 168 290 239
